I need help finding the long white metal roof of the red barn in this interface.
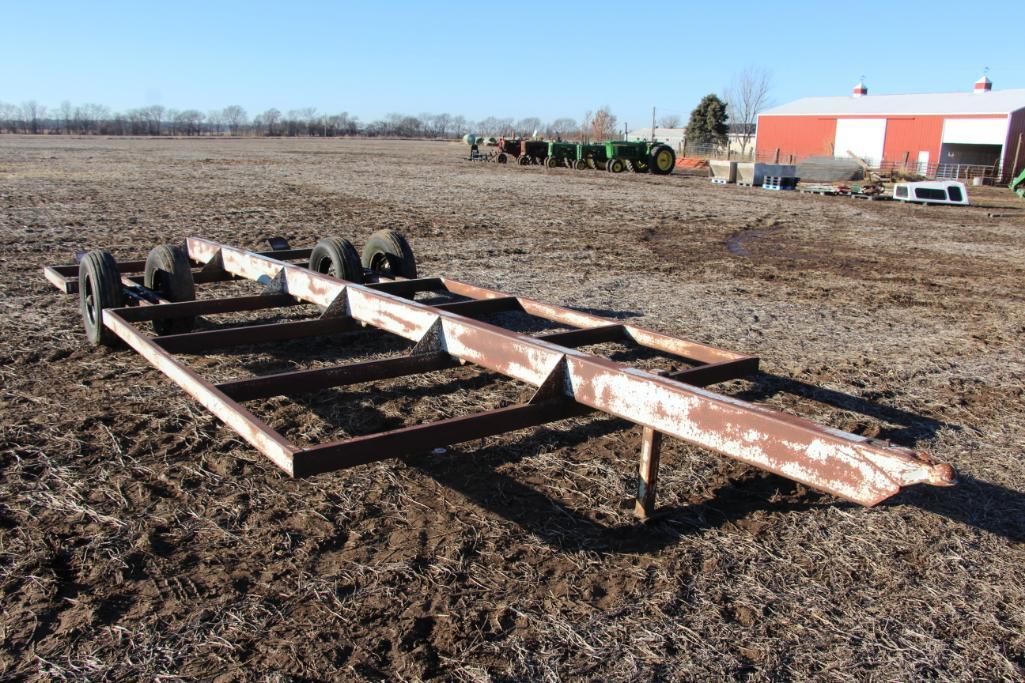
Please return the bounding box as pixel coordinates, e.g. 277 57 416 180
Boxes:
761 88 1025 116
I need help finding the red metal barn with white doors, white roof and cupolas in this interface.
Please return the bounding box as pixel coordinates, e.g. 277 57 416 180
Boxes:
755 76 1025 182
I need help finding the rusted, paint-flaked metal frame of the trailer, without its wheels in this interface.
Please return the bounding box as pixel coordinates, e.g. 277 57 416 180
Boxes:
39 233 953 516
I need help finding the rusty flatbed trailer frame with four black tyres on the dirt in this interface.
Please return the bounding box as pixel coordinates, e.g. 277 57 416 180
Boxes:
44 231 954 518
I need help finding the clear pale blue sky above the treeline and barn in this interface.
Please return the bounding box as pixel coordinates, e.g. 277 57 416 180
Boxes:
0 0 1025 127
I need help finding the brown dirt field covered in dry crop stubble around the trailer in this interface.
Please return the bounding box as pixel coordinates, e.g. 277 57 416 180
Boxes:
0 136 1025 681
